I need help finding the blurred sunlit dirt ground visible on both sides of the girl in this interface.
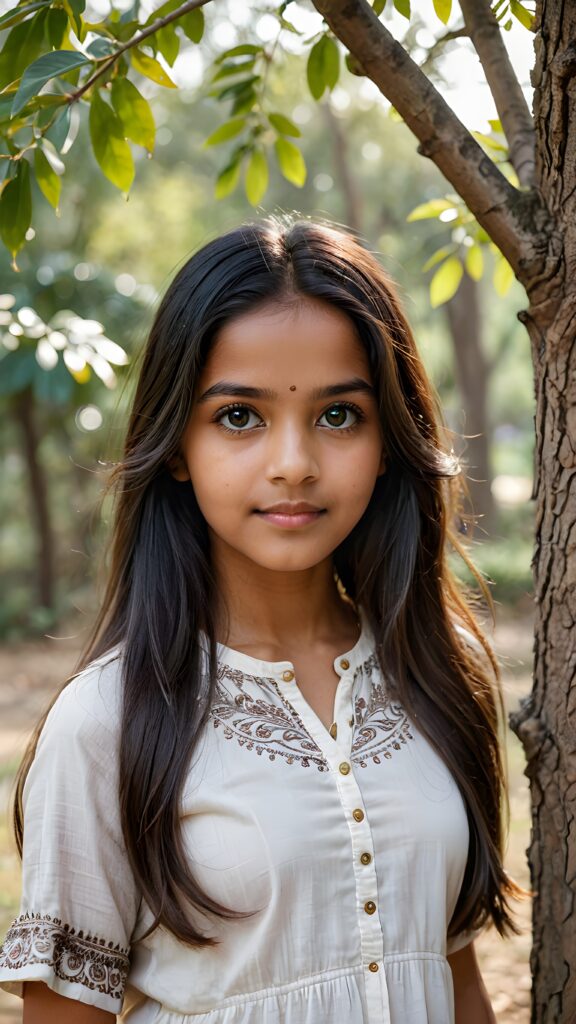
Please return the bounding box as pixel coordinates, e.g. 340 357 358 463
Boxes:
0 602 532 1024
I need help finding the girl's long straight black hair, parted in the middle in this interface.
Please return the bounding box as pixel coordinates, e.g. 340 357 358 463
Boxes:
14 221 526 946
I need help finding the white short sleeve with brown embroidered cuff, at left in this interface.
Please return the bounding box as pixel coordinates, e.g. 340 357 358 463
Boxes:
0 658 139 1014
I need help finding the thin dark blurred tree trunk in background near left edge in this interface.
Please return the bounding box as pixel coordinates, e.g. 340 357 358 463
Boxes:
12 388 54 609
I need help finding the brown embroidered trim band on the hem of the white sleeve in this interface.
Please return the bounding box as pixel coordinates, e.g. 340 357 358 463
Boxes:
0 913 130 1000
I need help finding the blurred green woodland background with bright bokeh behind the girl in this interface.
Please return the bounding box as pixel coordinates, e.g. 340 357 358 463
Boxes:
0 0 534 1024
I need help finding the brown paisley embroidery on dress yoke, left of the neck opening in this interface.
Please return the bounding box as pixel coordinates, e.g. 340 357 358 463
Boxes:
211 665 328 771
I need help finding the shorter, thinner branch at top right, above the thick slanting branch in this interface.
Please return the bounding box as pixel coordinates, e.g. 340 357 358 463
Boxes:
460 0 536 187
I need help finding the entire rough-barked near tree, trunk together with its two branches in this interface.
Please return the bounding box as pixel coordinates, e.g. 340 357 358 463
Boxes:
305 0 576 1024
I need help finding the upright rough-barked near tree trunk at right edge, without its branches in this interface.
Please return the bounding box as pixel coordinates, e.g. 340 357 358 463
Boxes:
510 0 576 1024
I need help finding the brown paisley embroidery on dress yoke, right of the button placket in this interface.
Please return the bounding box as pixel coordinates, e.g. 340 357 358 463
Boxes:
351 654 414 768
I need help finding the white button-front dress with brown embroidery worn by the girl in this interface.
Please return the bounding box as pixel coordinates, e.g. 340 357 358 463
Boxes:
0 616 480 1024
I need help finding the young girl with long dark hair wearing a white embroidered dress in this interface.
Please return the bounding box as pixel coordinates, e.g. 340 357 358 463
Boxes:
0 214 524 1024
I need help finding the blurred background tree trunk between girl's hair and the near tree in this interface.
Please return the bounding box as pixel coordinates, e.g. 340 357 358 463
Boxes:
446 273 496 538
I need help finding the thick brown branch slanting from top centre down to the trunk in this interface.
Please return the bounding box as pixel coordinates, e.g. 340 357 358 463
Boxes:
313 0 537 271
